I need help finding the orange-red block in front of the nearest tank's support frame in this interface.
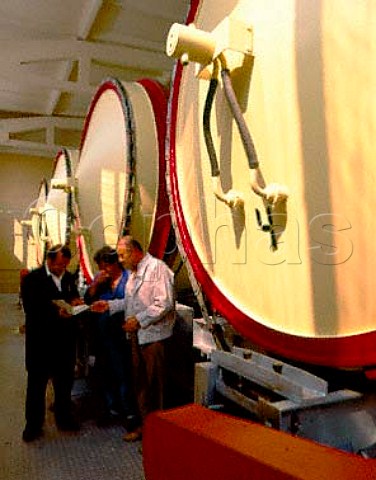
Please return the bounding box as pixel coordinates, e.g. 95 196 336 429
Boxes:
143 405 376 480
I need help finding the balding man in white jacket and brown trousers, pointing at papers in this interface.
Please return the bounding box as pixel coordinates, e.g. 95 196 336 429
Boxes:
92 236 175 441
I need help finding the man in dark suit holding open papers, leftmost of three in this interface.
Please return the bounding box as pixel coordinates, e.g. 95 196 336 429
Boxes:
21 245 82 442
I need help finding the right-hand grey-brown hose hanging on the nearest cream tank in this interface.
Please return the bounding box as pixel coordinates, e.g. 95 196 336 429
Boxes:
221 68 259 169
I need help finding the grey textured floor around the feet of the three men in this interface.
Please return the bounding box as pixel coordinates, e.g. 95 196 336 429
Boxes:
0 294 144 480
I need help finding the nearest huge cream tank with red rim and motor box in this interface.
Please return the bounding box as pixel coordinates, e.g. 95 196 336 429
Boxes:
167 0 376 367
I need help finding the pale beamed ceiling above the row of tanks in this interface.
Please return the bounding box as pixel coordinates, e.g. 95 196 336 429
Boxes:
0 0 190 157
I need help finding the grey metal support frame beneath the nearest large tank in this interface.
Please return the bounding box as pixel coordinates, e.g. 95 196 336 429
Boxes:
195 336 376 458
